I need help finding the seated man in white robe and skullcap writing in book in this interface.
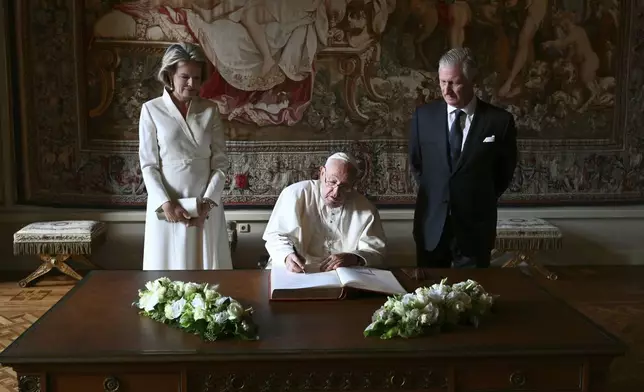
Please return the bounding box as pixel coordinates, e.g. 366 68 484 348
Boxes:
263 153 386 272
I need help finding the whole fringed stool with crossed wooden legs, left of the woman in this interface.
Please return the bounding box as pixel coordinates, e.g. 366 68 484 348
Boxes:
13 220 107 287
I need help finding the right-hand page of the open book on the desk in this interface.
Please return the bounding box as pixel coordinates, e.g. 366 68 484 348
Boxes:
336 267 407 294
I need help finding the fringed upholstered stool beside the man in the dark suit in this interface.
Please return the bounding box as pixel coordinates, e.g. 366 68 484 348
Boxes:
492 218 563 280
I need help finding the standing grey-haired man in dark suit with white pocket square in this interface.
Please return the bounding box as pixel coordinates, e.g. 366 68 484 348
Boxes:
409 48 517 268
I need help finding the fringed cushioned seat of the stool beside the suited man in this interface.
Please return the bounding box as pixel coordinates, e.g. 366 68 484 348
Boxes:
495 218 563 251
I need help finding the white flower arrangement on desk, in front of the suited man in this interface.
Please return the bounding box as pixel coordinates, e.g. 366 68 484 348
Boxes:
364 279 498 339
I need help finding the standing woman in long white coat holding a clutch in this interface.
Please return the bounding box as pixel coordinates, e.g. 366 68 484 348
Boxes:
139 43 232 270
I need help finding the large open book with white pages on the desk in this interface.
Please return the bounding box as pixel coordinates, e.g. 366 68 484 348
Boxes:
270 264 407 300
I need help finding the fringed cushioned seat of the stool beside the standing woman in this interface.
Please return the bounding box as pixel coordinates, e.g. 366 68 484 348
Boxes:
13 220 107 255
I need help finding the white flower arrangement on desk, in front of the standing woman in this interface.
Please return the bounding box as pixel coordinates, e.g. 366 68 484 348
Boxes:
132 277 258 341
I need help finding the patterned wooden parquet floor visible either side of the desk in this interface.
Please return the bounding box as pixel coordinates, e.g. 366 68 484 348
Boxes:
0 266 644 392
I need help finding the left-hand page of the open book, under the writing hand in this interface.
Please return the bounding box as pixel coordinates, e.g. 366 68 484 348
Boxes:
271 265 342 290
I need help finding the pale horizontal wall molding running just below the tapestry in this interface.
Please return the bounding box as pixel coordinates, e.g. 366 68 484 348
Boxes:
0 205 644 223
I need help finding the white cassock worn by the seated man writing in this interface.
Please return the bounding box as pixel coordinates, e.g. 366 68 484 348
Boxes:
262 180 386 268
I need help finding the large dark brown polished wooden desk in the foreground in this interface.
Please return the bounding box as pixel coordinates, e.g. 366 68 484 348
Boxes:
0 268 625 392
